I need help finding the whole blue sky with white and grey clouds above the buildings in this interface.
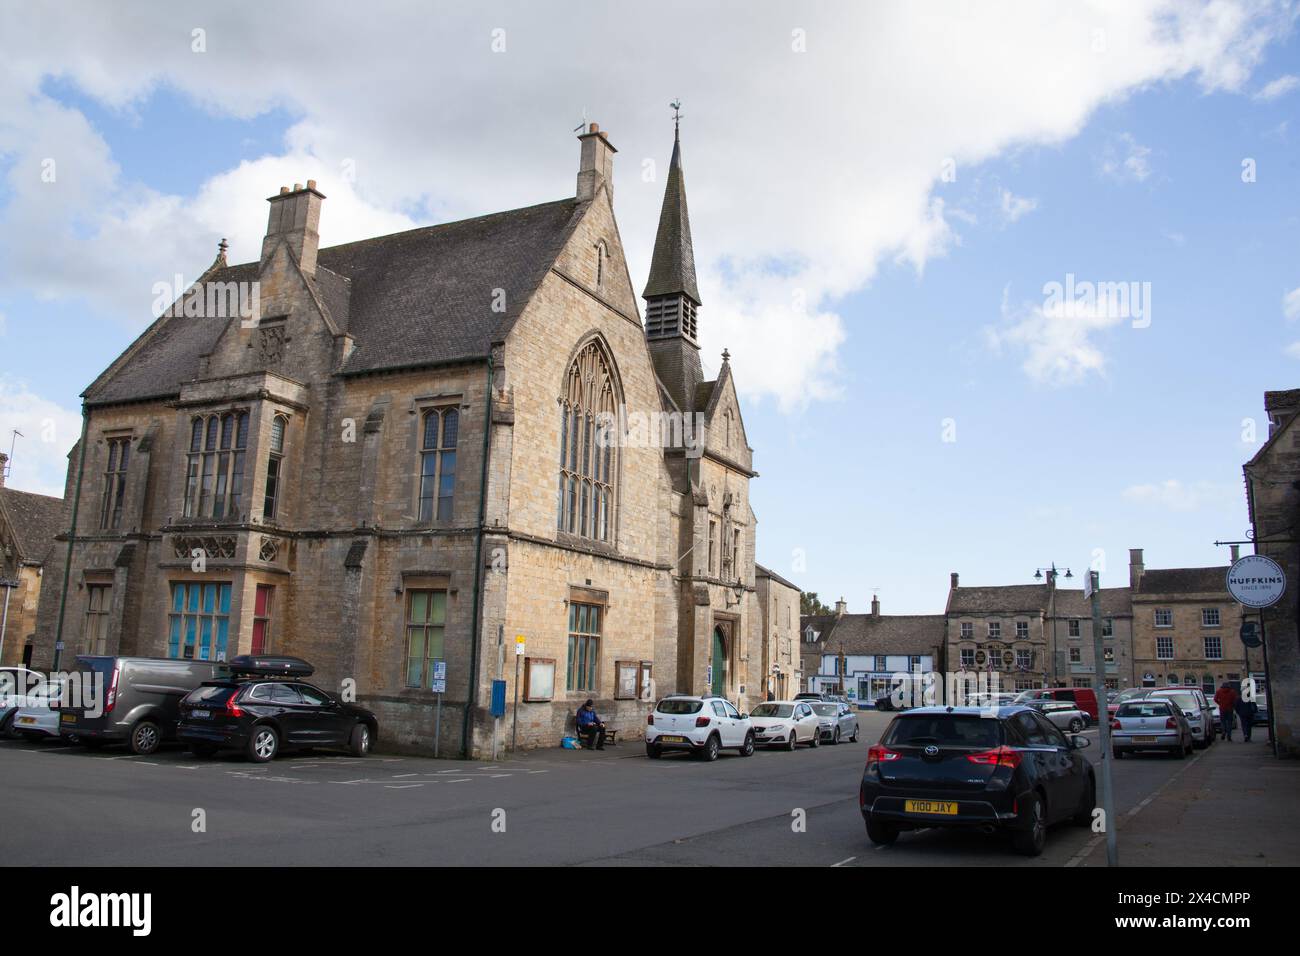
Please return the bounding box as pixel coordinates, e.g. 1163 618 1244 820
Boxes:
0 0 1300 613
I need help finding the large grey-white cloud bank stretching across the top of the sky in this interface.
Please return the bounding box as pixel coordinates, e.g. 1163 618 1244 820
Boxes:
0 0 1287 407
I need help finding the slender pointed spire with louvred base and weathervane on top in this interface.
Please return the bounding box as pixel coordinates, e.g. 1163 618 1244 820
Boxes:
641 101 701 343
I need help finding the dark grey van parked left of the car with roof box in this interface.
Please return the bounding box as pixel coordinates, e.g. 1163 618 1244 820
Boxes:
59 656 230 754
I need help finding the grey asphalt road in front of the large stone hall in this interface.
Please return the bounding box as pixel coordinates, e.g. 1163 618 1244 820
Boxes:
0 713 1188 866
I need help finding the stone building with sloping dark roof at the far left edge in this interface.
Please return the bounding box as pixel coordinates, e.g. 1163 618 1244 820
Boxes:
0 454 64 665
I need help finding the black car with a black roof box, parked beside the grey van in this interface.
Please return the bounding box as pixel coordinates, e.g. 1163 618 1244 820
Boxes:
177 656 380 763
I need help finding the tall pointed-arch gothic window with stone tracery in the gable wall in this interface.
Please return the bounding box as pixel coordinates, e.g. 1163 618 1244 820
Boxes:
556 342 619 541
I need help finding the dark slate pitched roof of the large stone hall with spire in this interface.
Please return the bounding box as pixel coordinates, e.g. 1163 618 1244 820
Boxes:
85 199 585 405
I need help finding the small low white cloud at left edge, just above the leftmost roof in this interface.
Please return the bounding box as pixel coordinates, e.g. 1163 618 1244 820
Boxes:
0 375 81 498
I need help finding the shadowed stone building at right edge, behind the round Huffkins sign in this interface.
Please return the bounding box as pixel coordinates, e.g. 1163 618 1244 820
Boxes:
1243 389 1300 757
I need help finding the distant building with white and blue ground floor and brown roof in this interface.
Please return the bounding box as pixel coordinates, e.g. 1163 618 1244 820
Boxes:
800 597 944 704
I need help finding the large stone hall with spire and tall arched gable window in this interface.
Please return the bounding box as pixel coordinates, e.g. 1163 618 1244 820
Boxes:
36 124 763 754
